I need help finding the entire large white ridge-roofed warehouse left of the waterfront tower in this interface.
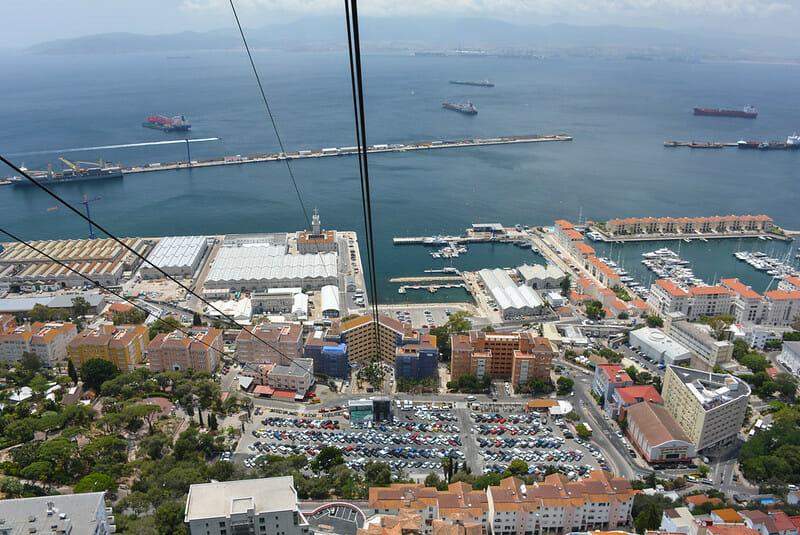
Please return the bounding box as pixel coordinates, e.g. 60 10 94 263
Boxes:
205 242 337 291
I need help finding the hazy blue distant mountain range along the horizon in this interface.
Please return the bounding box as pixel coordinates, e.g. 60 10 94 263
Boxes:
25 17 797 58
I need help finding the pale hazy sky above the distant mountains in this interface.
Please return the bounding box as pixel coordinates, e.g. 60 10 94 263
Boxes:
0 0 800 48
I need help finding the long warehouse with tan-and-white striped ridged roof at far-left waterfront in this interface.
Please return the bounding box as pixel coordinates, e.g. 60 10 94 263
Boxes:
0 238 149 291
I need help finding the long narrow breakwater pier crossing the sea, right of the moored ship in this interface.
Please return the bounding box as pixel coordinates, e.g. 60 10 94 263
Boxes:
115 134 572 174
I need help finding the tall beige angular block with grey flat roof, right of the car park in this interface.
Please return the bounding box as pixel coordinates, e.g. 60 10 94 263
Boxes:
661 366 750 451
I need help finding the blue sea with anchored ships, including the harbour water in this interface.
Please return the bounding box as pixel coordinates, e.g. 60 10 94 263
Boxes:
0 50 800 302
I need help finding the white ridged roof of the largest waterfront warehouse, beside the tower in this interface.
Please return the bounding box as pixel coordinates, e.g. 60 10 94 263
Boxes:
206 244 337 283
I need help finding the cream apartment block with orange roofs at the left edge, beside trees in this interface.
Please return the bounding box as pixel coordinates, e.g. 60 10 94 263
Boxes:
0 318 78 368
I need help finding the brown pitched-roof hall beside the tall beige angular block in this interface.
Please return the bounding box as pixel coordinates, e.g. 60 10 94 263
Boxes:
626 401 695 463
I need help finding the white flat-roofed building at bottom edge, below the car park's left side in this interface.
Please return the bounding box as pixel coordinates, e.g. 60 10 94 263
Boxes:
184 476 309 535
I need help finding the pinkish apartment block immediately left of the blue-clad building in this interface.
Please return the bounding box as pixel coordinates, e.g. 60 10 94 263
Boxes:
236 322 303 366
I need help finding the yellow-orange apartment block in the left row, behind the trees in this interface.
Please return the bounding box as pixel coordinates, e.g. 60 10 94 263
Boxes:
67 325 148 372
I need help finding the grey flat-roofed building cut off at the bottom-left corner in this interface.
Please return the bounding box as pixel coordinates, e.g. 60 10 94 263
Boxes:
0 492 117 535
